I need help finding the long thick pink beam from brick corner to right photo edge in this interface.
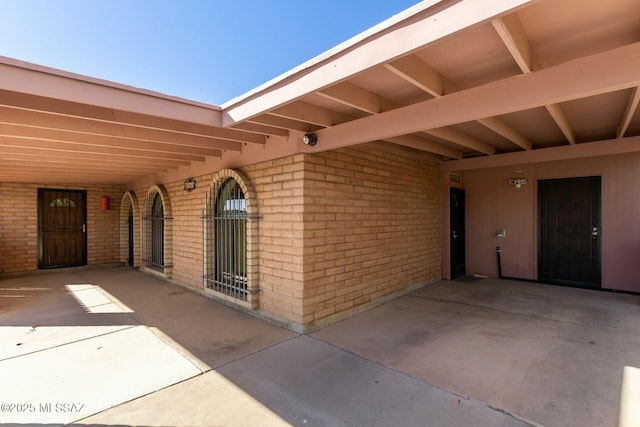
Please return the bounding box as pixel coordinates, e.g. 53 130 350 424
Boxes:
305 43 640 151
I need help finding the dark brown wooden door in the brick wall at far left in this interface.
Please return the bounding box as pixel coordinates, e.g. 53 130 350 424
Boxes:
38 188 87 268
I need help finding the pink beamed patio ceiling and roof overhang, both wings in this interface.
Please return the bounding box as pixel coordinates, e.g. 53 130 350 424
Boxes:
0 0 640 183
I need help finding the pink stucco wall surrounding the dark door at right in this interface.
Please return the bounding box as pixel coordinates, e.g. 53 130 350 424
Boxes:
463 154 640 292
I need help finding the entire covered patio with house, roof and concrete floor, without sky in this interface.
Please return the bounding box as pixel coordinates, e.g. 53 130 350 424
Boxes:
0 0 640 426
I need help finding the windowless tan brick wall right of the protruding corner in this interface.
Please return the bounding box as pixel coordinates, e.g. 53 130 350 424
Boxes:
303 148 441 327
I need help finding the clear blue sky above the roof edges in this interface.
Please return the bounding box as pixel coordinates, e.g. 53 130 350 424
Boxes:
0 0 419 105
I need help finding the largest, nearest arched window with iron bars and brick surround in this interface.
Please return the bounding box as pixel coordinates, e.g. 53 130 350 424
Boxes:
203 170 258 308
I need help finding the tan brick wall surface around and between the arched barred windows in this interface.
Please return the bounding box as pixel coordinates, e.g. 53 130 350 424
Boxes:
135 155 304 324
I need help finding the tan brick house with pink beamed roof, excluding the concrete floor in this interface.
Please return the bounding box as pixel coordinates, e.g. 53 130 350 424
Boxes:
0 0 640 331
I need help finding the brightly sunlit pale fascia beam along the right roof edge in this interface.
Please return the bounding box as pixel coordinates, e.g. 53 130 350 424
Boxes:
222 0 531 126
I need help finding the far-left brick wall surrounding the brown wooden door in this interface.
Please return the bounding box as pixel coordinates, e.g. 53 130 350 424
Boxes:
0 183 124 273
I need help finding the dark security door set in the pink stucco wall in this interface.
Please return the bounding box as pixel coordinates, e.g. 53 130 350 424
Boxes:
538 177 601 288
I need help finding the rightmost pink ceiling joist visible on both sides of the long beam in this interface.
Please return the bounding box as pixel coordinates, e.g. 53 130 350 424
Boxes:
491 13 576 144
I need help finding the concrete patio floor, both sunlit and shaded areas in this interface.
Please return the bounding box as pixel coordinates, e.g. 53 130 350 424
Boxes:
0 267 640 427
